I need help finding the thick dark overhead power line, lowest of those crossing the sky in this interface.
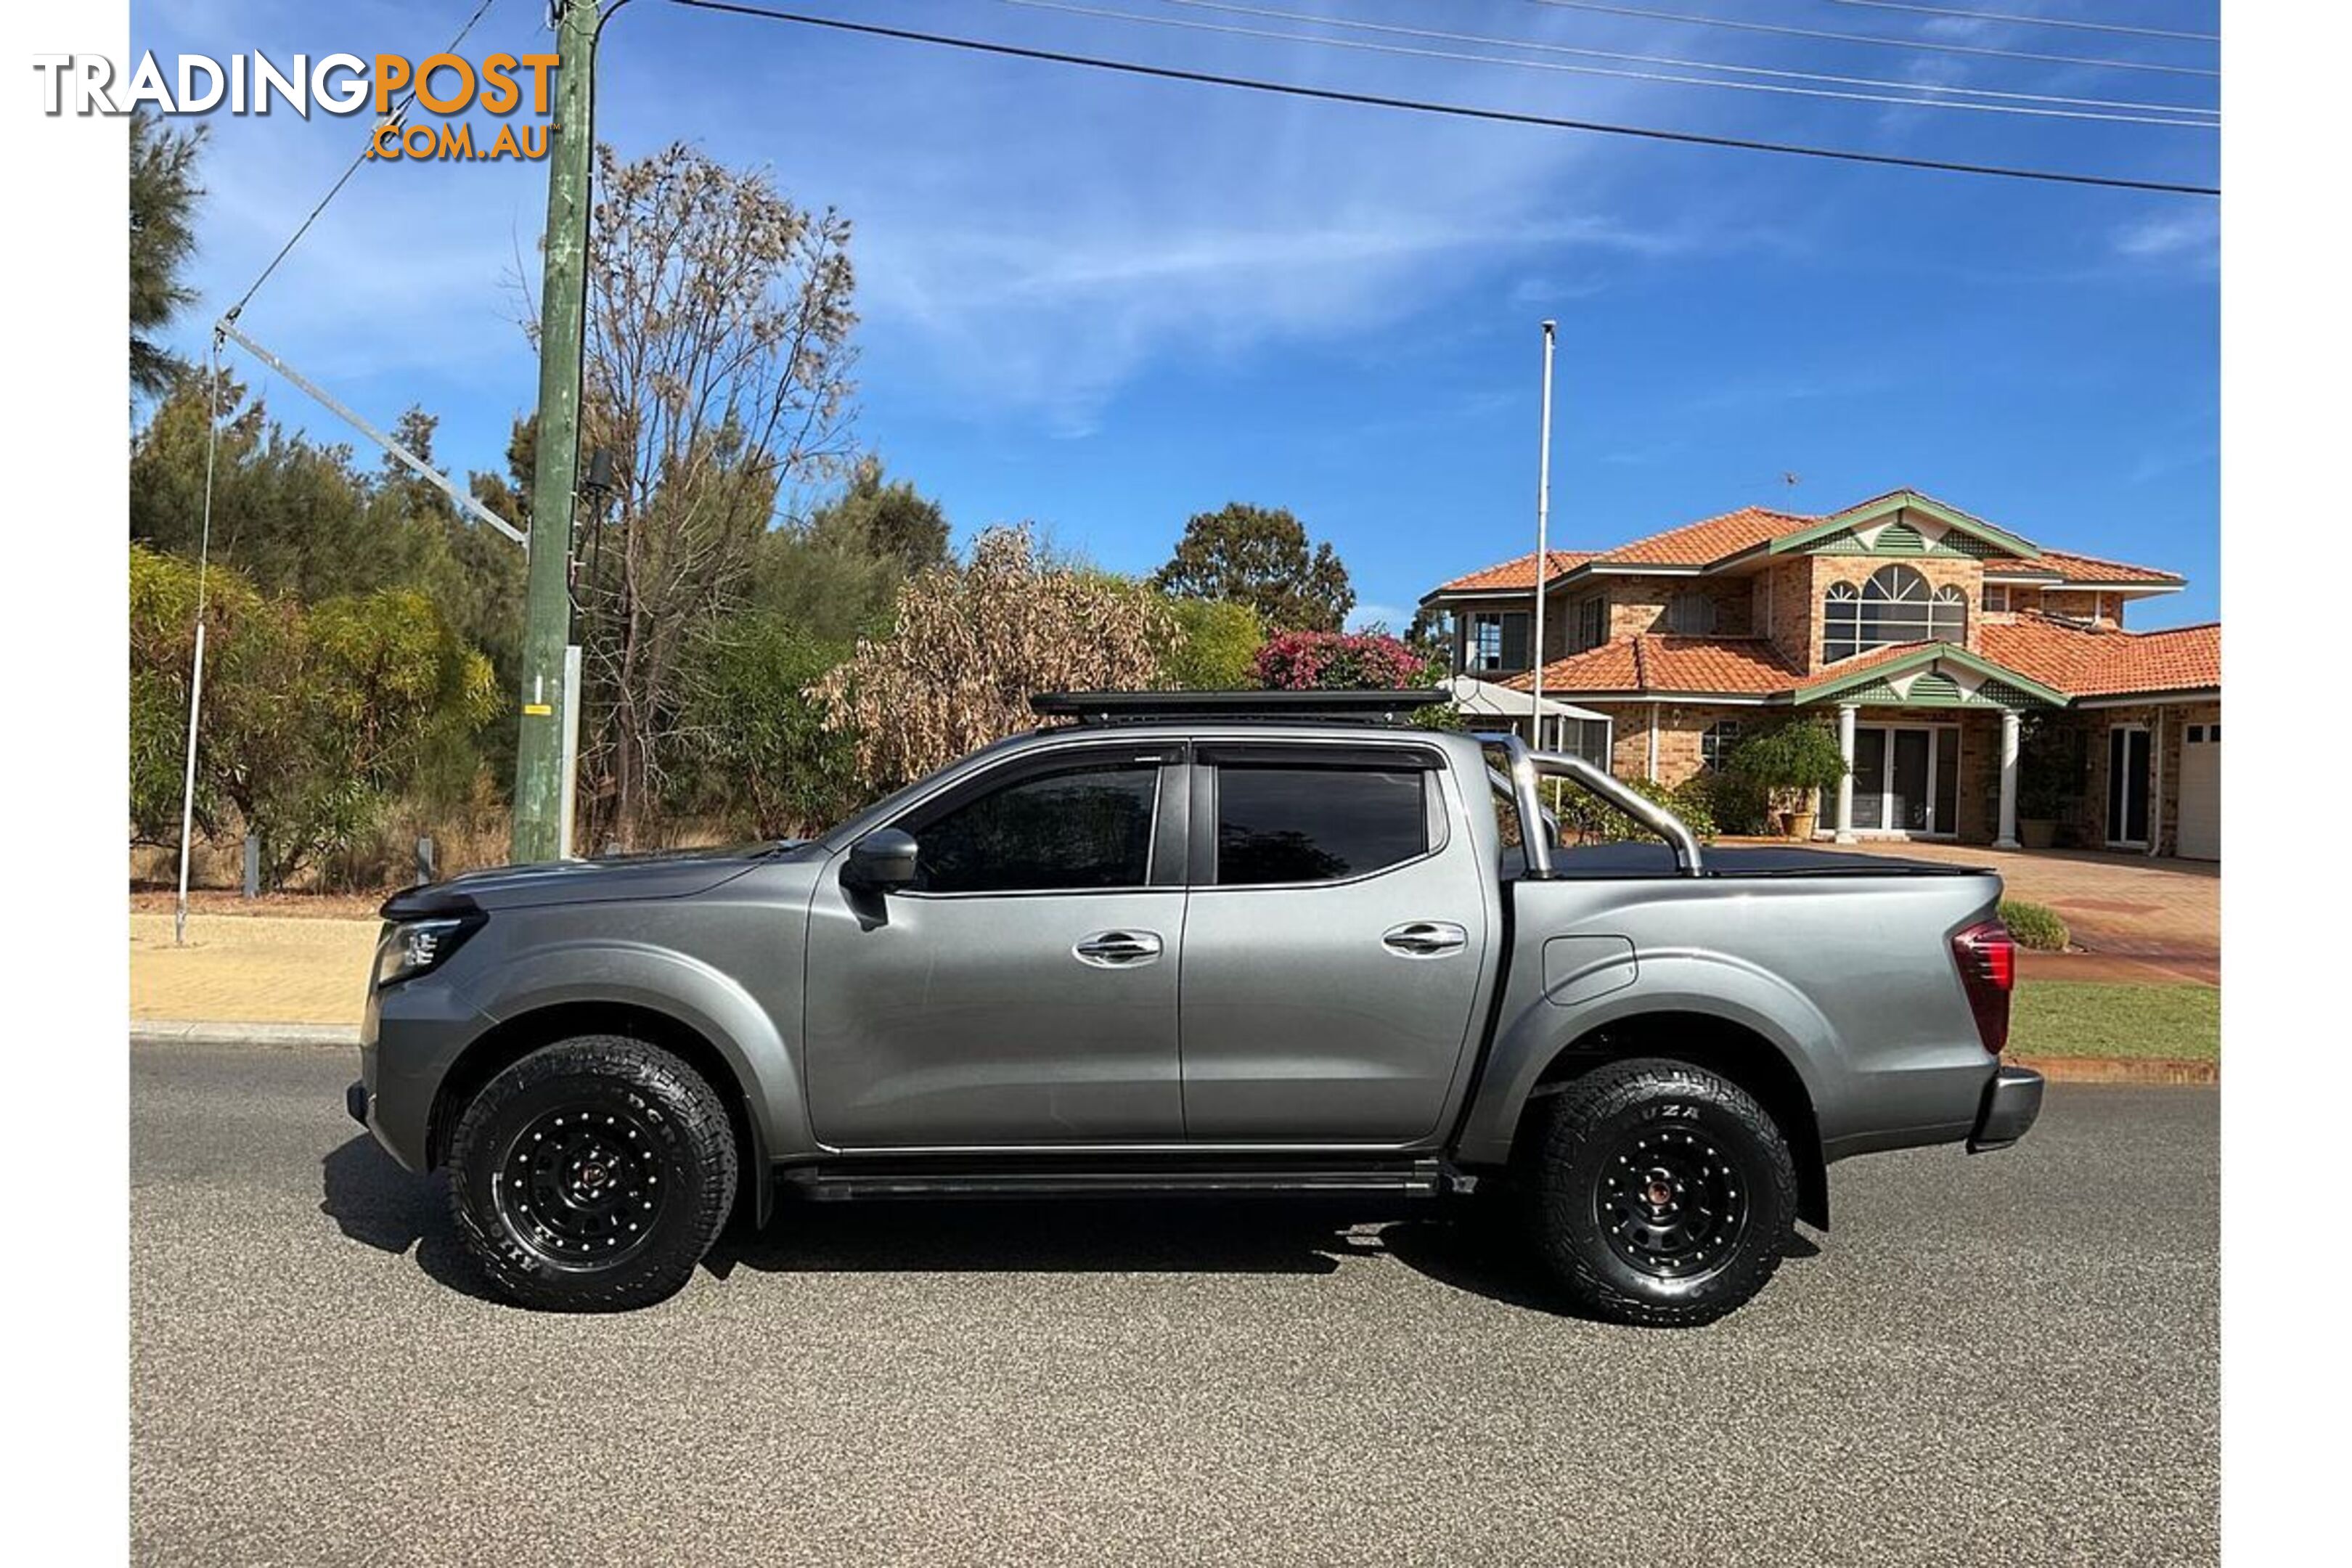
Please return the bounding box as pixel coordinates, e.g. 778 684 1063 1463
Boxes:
673 0 2221 195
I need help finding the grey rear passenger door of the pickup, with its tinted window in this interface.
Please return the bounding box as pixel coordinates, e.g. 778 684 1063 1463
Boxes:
1180 740 1489 1145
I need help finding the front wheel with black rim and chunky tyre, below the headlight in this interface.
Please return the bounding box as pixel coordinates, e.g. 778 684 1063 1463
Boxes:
449 1034 736 1312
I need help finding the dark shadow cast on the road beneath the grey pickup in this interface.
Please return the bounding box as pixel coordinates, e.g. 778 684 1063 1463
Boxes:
320 1135 1818 1316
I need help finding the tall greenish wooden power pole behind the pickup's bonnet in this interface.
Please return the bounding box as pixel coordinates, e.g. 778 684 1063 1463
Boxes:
508 0 597 862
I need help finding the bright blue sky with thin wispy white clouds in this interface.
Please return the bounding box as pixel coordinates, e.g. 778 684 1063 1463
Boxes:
134 0 2221 628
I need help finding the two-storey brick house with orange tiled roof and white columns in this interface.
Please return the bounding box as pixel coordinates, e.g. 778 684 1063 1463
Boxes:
1421 489 2221 860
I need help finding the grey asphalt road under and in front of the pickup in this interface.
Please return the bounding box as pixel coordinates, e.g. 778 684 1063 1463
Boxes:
131 1044 2218 1568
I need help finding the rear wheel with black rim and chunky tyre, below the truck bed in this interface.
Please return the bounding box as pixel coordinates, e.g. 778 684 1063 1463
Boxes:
1522 1058 1797 1328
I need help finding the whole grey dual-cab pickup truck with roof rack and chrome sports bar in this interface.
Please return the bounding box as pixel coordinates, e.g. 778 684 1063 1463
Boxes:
351 691 2041 1323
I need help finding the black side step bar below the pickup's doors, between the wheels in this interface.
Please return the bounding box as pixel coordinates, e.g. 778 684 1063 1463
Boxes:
776 1159 1447 1204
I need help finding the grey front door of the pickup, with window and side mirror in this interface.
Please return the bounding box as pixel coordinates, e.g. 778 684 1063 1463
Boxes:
802 746 1188 1150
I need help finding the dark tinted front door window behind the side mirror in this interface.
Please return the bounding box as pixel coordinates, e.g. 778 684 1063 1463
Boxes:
915 761 1159 894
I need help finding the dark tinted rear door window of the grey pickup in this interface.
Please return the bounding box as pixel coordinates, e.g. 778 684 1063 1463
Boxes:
1216 764 1430 886
